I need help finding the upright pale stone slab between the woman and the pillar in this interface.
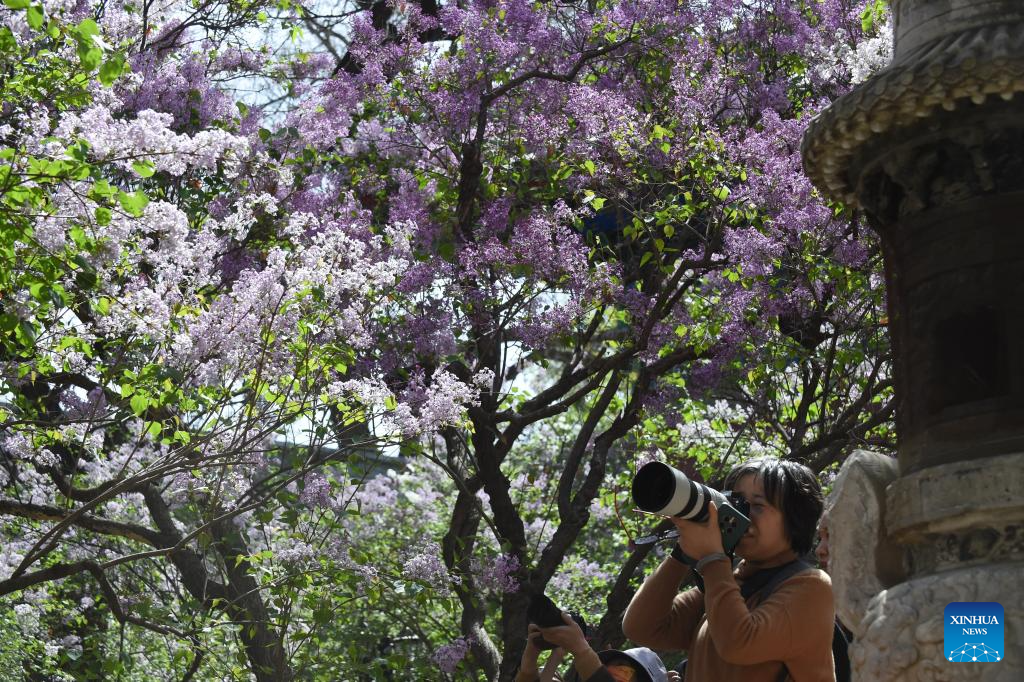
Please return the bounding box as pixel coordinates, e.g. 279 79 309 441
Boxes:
825 451 904 638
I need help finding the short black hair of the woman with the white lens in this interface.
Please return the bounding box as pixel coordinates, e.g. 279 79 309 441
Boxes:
725 458 824 556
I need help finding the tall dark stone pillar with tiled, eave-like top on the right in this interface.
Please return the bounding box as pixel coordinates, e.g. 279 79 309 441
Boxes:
803 0 1024 682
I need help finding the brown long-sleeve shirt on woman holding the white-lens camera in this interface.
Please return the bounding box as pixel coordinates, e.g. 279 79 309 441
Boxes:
623 559 836 682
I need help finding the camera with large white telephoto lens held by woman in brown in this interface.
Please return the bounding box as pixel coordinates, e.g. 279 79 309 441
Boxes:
633 462 751 563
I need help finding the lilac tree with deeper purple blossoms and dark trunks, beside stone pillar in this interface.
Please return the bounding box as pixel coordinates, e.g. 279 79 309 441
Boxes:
278 2 892 678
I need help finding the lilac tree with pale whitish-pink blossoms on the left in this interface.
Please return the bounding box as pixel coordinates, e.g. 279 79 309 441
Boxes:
0 3 477 679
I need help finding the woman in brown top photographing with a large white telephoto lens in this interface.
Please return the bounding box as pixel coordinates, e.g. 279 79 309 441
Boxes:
623 460 836 682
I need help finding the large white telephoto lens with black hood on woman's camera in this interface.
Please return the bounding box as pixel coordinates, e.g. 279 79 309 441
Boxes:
633 462 728 521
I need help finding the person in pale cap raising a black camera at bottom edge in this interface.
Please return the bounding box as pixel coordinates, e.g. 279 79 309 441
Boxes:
515 612 680 682
